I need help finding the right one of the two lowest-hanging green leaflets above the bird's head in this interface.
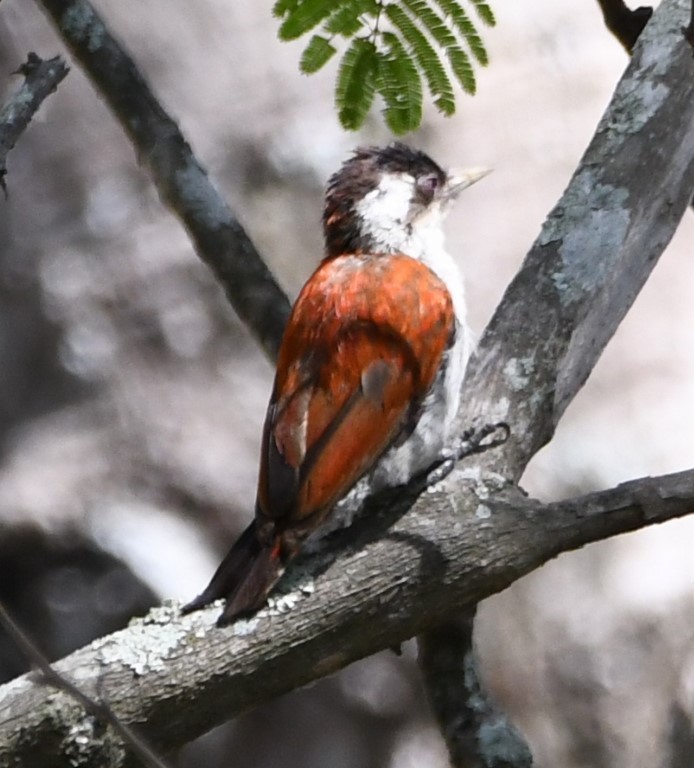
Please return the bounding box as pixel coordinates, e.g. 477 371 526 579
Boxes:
376 32 422 136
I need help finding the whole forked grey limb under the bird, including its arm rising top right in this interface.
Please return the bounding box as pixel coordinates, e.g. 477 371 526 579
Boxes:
0 0 694 766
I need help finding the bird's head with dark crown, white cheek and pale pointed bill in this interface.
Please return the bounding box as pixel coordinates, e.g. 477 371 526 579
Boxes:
323 142 489 258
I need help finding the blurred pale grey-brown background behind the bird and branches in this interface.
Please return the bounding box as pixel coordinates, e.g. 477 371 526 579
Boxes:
0 0 694 768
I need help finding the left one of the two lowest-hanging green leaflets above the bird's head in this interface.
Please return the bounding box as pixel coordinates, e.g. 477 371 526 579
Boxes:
335 38 378 131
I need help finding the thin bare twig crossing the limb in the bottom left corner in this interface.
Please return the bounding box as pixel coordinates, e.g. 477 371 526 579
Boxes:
0 603 169 768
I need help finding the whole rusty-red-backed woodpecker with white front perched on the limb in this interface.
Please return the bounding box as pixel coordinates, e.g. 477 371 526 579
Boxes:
183 143 488 624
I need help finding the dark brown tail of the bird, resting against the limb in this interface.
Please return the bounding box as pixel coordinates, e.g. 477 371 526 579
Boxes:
182 521 284 625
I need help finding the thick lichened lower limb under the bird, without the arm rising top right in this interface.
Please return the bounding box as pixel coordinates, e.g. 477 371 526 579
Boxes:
0 470 694 768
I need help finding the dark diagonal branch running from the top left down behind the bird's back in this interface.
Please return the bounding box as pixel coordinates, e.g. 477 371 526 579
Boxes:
37 0 289 359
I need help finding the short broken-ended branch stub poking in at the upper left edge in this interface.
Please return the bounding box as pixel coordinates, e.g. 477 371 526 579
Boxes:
0 53 70 194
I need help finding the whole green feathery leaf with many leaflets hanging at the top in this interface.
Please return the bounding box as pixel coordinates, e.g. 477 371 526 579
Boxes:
273 0 496 134
